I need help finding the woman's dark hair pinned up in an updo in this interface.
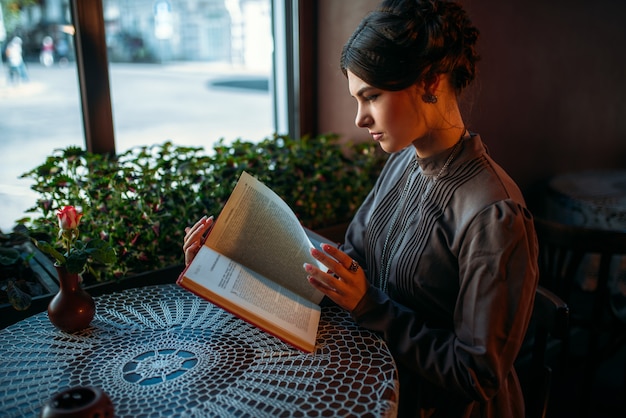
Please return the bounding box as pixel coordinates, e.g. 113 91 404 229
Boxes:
341 0 479 93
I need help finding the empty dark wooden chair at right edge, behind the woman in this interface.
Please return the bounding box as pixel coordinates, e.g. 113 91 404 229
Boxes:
535 218 626 417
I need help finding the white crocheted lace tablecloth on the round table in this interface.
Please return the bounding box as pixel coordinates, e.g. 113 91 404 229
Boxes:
0 284 398 417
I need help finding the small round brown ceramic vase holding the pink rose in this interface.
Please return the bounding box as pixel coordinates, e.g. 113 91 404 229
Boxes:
48 265 96 332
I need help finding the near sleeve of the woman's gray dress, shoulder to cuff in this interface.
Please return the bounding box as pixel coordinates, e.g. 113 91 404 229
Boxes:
352 200 538 400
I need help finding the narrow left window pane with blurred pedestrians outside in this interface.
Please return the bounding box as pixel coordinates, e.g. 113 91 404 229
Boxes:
0 0 85 232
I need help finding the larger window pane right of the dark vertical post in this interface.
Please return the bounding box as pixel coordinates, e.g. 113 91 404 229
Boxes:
103 0 274 151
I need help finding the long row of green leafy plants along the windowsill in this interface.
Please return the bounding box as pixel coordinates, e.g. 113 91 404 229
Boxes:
18 135 384 279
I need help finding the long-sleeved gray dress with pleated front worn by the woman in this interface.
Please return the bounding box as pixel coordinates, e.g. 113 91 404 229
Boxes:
342 135 538 417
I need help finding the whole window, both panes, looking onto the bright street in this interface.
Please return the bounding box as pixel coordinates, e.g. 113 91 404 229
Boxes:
0 0 278 231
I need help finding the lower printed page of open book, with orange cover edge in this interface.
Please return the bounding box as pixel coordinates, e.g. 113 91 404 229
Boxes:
178 246 320 352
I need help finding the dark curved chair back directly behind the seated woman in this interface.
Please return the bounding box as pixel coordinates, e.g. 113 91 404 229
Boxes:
516 286 569 418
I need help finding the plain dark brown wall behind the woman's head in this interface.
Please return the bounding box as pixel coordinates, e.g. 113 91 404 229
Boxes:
318 0 626 202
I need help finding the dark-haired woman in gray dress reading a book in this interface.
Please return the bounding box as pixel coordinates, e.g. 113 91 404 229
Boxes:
184 0 537 418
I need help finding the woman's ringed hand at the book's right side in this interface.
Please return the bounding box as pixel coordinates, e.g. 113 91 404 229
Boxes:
304 244 369 312
